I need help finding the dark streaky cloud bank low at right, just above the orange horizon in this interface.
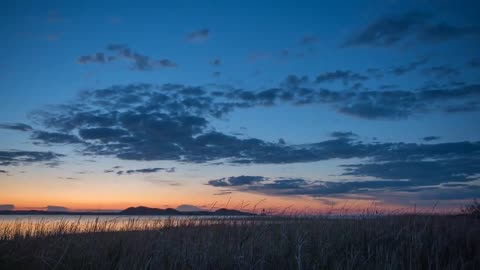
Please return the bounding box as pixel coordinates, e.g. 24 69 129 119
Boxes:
207 136 480 199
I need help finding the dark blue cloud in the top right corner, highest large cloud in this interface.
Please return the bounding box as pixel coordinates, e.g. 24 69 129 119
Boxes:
343 12 480 47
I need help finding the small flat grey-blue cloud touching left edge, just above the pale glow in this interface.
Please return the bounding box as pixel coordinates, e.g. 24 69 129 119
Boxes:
0 150 64 166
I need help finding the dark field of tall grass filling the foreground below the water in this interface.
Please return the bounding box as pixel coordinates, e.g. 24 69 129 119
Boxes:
0 216 480 270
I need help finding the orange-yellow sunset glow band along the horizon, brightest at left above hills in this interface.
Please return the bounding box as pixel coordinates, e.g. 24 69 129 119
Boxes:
0 172 464 213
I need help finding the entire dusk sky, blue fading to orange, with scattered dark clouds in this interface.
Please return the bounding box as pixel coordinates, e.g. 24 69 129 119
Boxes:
0 0 480 212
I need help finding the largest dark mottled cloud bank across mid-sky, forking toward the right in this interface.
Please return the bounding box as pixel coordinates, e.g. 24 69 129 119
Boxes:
25 77 480 164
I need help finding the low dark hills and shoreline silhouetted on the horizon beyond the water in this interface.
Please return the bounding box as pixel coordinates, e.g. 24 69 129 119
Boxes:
0 206 256 216
